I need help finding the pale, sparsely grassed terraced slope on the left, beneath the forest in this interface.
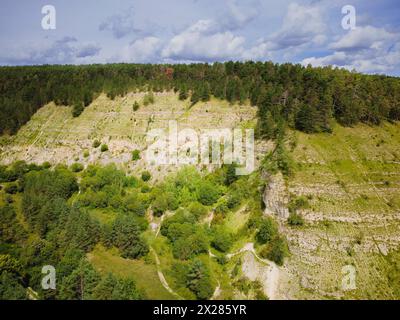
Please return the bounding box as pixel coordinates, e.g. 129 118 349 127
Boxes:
0 92 268 181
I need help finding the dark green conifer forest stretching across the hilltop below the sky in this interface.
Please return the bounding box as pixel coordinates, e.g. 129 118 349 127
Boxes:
0 62 400 137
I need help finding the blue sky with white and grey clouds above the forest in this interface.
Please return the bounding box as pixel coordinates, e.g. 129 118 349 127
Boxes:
0 0 400 76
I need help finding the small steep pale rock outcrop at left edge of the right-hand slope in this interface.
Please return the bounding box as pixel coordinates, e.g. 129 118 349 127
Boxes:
263 173 289 219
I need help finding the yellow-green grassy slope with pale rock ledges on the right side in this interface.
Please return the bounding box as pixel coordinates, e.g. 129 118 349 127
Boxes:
287 123 400 299
